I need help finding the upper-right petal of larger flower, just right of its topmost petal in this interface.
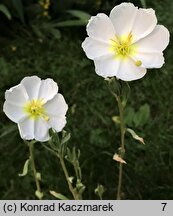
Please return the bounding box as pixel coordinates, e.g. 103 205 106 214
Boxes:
131 8 157 42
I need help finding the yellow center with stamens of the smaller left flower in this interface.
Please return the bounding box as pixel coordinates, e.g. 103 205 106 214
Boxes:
24 99 49 121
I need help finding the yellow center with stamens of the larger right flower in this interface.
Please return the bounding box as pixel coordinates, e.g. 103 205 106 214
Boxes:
110 32 142 67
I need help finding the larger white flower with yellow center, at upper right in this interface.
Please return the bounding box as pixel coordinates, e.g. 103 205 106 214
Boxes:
82 3 169 81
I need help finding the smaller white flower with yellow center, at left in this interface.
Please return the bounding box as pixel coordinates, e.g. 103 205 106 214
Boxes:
3 76 68 141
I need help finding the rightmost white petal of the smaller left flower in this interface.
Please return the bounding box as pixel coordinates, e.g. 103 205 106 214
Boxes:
44 94 68 116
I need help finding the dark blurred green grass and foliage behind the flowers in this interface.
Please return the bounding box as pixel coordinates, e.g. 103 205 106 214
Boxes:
0 0 173 199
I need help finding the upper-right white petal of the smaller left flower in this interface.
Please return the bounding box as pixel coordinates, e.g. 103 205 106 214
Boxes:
38 78 58 102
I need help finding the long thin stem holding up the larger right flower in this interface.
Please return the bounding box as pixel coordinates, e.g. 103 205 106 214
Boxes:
116 96 125 200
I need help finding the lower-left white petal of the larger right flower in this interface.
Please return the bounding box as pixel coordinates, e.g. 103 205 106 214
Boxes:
94 54 121 78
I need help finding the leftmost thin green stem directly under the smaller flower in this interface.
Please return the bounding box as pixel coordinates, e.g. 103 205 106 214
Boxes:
28 142 41 199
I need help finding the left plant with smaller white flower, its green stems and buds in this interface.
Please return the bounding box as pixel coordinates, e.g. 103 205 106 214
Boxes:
3 76 83 199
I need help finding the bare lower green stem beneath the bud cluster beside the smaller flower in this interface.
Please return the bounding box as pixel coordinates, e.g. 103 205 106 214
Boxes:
58 155 80 200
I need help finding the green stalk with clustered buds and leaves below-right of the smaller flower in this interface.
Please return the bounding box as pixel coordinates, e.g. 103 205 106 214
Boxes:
43 129 85 200
